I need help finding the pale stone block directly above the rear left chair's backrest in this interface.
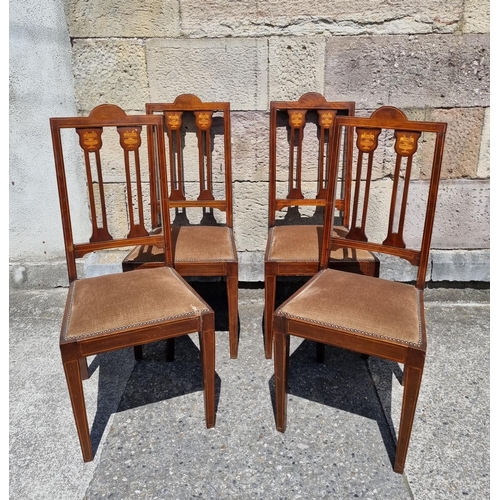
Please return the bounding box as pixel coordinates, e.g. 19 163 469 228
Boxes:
146 38 269 110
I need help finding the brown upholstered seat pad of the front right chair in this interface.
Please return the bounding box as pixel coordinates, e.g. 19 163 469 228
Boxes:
275 269 423 347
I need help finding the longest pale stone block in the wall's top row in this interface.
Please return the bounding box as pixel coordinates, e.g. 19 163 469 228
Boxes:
180 0 462 37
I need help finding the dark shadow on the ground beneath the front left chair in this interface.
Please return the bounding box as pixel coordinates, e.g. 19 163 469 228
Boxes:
89 335 221 450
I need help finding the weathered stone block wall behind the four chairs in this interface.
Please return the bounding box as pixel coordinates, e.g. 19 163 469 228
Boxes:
9 0 490 281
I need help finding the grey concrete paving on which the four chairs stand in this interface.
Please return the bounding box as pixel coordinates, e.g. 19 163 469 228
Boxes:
9 283 490 500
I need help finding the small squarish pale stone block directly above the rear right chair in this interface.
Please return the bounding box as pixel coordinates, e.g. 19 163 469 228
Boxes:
269 37 325 101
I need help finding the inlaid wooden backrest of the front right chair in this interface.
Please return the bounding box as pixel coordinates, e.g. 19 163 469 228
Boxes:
321 106 447 289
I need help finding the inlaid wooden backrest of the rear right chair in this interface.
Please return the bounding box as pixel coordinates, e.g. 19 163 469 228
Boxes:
269 92 355 227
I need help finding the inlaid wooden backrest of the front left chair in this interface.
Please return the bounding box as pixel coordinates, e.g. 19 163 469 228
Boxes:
50 104 172 282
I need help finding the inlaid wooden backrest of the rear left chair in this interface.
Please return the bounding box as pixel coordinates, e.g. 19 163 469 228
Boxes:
146 94 233 227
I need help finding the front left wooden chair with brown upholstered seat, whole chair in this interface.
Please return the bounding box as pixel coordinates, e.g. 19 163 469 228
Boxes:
50 104 215 462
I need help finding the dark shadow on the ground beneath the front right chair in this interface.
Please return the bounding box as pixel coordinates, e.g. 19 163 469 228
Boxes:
269 340 402 464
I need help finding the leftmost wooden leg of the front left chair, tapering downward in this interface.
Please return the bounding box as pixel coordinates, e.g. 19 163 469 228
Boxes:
63 359 94 462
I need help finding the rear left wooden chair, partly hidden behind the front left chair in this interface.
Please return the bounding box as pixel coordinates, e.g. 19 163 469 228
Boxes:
123 94 238 358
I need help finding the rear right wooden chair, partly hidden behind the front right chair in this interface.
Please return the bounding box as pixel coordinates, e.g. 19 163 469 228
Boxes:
264 92 379 358
